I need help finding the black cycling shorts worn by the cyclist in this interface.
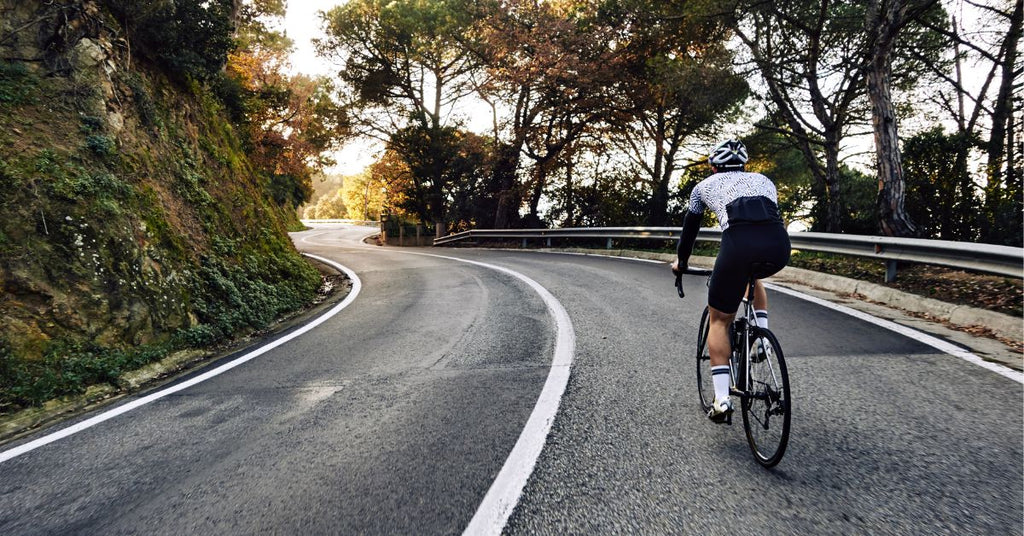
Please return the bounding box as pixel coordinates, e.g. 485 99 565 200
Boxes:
708 223 791 313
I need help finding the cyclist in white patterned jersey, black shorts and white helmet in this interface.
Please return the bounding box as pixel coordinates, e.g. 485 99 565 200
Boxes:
672 139 790 422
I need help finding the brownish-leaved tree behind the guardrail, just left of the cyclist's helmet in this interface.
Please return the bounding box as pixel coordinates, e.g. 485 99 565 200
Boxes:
606 0 749 225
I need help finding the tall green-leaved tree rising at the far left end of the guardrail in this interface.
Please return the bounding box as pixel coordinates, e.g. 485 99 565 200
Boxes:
317 0 477 237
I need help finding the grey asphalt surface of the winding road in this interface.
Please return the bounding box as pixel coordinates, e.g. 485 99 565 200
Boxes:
0 226 1024 535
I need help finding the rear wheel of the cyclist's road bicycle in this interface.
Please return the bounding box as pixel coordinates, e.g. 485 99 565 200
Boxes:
740 329 792 467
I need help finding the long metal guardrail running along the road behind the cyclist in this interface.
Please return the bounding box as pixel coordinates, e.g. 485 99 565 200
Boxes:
434 228 1024 281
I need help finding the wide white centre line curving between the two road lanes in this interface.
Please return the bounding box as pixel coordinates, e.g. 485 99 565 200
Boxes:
393 251 575 536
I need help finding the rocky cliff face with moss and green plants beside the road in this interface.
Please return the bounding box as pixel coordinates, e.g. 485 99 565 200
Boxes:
0 0 318 411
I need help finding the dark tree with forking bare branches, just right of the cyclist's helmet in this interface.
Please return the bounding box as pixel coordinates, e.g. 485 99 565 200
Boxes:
726 0 865 233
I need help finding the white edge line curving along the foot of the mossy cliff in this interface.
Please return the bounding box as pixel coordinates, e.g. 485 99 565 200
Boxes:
0 253 362 463
